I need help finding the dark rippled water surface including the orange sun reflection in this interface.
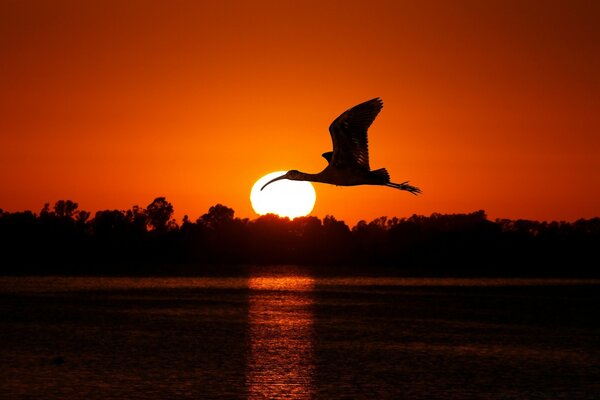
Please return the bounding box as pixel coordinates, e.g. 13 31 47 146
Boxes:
0 268 600 399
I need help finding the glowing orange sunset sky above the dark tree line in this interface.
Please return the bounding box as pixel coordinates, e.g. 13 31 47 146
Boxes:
0 0 600 225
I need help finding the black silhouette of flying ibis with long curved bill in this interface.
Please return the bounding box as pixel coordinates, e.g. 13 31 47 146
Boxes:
260 97 421 195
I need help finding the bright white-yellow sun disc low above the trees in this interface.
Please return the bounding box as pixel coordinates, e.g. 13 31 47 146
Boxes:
250 171 317 218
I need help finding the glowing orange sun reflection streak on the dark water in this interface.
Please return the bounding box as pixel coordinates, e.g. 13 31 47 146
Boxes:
246 276 314 399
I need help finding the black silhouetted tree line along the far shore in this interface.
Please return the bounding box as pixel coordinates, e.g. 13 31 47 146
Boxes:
0 197 600 276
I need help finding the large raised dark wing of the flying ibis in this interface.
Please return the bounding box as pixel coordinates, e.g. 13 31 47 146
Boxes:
328 98 383 171
